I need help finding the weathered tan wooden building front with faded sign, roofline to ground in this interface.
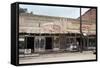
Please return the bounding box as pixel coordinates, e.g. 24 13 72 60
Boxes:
19 9 96 53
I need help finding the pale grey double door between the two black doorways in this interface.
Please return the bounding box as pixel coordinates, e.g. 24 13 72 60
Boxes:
34 36 45 52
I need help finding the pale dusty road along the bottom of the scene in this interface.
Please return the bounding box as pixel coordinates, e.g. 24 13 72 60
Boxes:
19 51 96 64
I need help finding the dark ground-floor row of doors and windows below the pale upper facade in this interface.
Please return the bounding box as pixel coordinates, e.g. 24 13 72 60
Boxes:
19 33 96 53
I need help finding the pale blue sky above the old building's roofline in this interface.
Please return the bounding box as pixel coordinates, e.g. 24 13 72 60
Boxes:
19 4 89 19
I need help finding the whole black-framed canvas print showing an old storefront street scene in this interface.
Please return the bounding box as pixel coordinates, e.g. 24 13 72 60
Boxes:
11 2 98 66
